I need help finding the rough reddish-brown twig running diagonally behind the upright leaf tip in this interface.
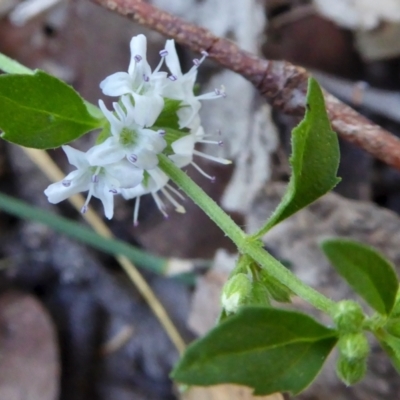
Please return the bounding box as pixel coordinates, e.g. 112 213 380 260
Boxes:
92 0 400 169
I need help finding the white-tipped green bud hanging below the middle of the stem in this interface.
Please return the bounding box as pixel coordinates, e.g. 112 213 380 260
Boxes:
221 273 252 314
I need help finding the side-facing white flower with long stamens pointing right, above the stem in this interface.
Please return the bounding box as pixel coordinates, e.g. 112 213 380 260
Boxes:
169 126 231 180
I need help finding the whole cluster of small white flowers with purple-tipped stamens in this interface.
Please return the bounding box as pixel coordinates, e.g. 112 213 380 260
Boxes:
45 35 230 225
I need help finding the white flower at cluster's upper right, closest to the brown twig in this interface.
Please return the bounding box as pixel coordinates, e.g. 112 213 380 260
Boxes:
162 40 226 128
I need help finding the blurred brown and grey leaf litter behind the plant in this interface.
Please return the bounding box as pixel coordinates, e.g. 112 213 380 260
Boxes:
0 0 400 400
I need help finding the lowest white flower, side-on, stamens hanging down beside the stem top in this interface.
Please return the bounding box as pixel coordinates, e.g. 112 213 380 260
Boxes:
121 167 185 226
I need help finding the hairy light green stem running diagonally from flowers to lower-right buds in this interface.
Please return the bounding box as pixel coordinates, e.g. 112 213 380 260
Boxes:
159 155 335 314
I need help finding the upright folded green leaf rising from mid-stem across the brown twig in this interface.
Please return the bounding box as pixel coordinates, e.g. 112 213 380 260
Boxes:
253 78 340 238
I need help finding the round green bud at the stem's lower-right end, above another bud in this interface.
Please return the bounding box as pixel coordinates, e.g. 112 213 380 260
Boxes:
333 300 365 333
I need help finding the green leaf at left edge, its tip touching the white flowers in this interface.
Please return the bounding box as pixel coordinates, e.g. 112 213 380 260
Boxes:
0 71 104 149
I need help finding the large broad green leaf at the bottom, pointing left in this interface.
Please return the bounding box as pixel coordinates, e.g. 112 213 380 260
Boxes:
172 307 337 395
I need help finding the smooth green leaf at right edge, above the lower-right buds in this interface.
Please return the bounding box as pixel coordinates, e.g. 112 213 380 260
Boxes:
321 239 399 315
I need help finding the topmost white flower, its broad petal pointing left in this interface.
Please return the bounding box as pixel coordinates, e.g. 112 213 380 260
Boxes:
100 35 167 125
